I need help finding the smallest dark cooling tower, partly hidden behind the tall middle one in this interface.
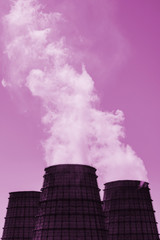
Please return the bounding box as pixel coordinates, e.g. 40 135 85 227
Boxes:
2 191 40 240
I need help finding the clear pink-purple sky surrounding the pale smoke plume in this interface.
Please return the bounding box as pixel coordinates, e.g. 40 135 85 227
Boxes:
0 0 160 236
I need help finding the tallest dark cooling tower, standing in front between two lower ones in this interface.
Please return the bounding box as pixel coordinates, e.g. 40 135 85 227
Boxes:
33 164 106 240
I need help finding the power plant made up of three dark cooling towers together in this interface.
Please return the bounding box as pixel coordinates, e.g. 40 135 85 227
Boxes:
2 164 159 240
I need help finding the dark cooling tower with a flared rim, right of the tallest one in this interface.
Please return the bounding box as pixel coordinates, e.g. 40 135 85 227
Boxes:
103 180 159 240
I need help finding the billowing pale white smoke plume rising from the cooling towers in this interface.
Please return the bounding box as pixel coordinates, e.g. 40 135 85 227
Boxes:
2 0 147 183
